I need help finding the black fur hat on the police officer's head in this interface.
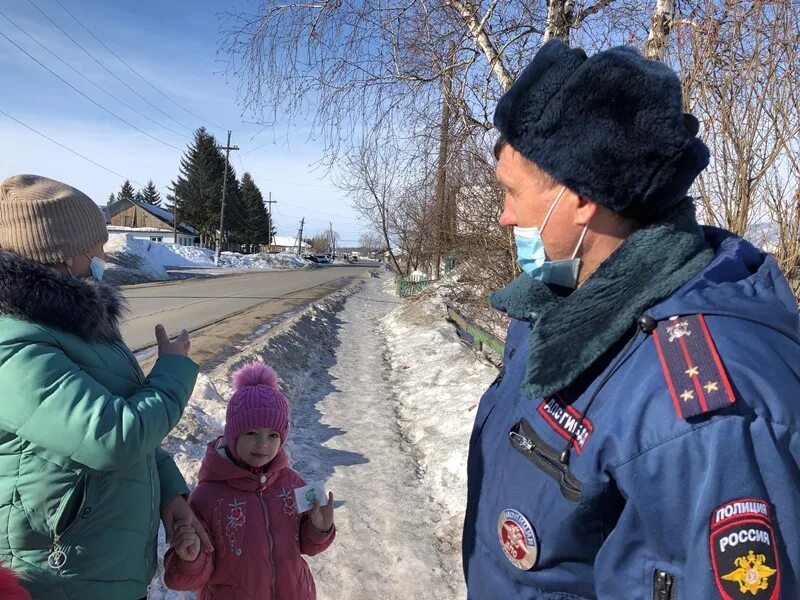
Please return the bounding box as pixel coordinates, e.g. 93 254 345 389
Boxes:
494 40 709 222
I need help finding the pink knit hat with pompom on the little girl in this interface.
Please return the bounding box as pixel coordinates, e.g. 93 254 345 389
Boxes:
225 362 291 458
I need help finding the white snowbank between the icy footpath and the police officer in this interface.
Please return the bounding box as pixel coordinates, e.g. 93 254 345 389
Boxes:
383 286 498 564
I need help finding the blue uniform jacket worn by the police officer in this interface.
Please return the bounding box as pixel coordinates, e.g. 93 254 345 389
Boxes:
463 231 800 600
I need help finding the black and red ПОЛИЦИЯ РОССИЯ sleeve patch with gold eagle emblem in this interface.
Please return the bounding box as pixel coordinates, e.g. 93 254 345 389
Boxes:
709 498 781 600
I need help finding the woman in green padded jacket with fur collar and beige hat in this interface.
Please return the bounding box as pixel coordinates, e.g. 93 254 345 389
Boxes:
0 175 211 600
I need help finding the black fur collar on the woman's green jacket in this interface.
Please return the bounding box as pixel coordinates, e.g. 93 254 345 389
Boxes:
0 250 127 342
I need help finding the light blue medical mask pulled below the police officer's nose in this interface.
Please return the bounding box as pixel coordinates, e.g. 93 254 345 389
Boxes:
514 186 589 289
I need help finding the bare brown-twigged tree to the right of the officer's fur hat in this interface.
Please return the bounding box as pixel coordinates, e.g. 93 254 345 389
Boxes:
676 0 800 242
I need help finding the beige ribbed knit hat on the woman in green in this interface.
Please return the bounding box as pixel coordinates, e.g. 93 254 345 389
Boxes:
0 175 108 264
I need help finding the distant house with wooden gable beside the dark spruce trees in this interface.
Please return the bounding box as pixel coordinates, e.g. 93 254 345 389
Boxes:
107 200 200 246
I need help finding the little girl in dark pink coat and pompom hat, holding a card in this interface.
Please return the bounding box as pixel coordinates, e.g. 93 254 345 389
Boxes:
164 363 336 600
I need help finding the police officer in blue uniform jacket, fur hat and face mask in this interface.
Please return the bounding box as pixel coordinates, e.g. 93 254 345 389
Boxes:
463 41 800 600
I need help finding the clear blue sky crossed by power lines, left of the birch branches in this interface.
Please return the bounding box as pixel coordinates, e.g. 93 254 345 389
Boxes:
0 0 364 245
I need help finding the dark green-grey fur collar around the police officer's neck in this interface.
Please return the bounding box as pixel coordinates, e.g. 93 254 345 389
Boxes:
490 201 714 398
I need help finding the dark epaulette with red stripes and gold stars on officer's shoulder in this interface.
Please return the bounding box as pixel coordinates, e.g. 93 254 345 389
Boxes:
653 315 736 419
